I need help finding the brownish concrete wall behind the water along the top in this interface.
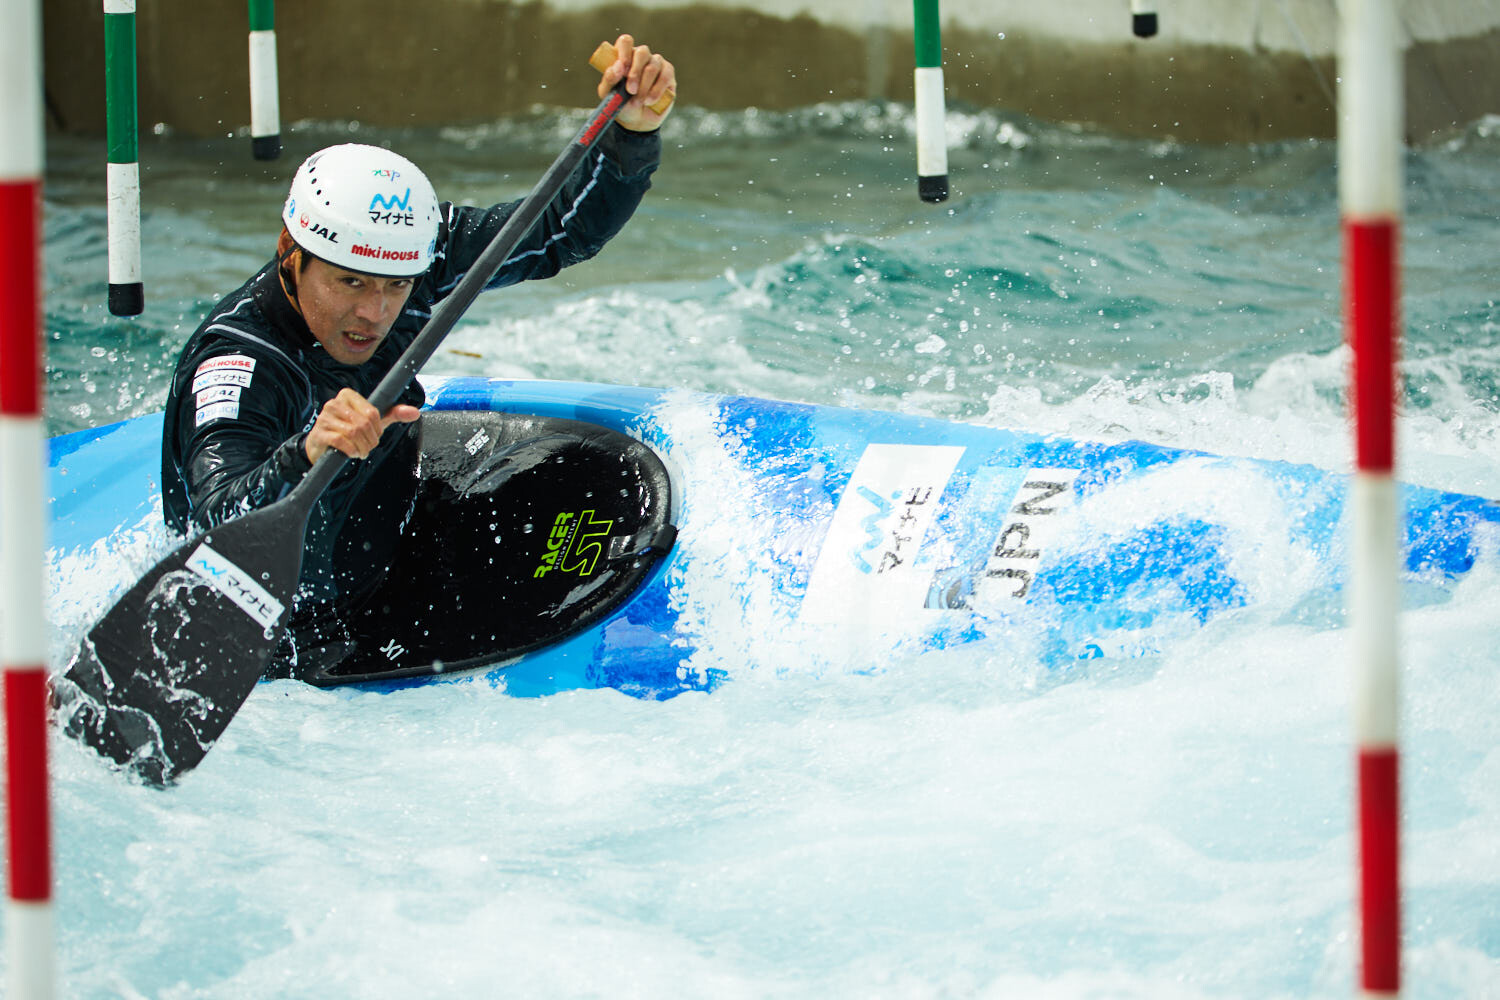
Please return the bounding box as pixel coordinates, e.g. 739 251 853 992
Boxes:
44 0 1500 141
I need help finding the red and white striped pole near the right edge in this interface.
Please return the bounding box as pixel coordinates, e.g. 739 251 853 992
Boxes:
1338 0 1406 997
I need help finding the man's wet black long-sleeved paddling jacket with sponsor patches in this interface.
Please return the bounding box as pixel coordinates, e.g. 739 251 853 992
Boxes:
162 126 662 604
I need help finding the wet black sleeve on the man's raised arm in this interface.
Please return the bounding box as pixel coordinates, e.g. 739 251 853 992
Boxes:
432 124 662 298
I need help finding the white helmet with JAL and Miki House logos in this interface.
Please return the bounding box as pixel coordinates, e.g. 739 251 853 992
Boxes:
282 142 438 277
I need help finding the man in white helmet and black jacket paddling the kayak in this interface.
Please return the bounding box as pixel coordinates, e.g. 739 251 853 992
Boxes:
162 34 677 676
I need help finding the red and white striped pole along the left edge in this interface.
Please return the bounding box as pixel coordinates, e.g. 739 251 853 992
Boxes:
0 0 54 1000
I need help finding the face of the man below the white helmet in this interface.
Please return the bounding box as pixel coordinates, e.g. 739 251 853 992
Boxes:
297 258 416 364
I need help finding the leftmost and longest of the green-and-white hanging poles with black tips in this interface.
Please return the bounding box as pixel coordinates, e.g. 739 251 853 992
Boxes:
104 0 146 316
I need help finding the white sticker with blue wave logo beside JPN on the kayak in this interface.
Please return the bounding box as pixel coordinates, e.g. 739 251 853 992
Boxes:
801 444 963 622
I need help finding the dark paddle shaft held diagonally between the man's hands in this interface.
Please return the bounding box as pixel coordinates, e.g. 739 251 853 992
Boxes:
288 81 630 511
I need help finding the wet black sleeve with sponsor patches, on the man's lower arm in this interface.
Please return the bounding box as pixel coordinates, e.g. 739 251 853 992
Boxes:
176 348 312 531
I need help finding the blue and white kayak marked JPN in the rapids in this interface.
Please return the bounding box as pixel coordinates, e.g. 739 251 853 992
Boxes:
50 378 1500 699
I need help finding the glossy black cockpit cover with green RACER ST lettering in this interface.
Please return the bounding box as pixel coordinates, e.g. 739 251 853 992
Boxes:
299 409 677 687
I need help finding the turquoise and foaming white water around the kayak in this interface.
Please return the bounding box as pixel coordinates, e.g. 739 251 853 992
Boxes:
20 103 1500 999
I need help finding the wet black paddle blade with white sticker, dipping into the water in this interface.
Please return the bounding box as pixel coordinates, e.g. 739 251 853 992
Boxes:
53 498 306 786
